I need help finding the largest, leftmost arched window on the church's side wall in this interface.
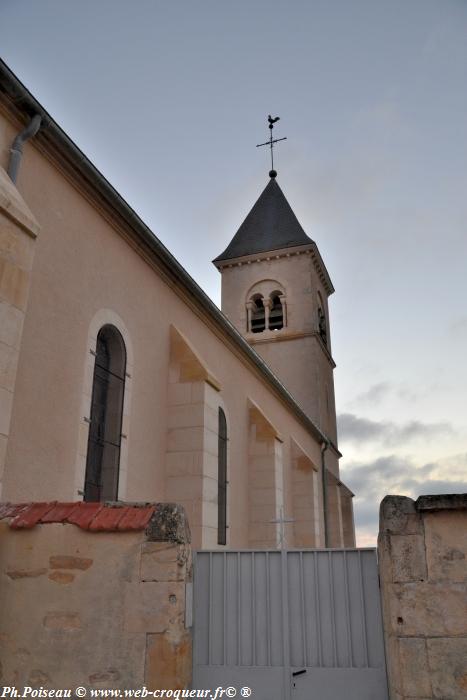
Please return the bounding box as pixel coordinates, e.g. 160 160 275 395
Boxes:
84 325 126 501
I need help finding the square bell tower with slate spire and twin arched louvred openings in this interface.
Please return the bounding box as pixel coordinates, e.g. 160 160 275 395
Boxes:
213 170 337 445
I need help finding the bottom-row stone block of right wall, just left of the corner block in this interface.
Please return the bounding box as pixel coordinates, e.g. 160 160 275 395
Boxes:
399 638 431 698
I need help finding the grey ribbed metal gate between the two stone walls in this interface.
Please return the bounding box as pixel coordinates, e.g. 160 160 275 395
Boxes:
193 549 388 700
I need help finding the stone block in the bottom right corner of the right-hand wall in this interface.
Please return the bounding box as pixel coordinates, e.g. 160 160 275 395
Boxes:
427 637 467 700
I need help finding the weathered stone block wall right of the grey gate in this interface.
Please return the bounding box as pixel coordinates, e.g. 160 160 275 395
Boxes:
378 494 467 700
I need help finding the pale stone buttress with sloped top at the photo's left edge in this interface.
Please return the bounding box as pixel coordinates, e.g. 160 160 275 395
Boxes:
0 167 39 495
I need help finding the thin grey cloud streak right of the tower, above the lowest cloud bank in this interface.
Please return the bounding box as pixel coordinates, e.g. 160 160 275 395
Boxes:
337 413 454 446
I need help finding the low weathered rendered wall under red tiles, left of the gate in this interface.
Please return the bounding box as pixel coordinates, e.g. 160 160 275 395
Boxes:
0 504 191 690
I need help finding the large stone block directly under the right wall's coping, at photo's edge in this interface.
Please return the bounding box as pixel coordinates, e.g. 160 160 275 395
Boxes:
425 511 467 582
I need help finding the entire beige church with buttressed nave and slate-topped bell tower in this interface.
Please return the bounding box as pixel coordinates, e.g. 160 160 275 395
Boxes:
0 62 355 549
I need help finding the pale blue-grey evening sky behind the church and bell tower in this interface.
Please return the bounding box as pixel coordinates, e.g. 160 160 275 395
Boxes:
0 0 467 546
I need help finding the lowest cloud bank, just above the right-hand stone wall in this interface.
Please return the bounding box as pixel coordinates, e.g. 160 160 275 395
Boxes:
341 452 467 546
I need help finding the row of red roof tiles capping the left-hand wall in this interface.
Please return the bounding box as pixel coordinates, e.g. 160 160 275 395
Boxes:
0 501 157 532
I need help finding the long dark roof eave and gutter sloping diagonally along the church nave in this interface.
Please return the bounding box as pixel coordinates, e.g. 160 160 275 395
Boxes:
0 59 342 457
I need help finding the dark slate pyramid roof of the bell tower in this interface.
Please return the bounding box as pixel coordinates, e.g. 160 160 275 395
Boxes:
213 177 313 263
